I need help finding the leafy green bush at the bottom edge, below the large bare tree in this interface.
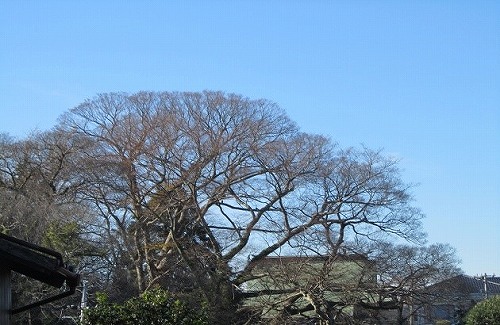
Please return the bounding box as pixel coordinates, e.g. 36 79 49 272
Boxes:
83 289 208 325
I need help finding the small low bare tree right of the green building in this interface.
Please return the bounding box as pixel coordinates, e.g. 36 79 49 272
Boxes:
361 243 461 324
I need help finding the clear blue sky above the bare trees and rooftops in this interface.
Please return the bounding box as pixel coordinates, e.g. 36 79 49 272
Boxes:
0 0 500 275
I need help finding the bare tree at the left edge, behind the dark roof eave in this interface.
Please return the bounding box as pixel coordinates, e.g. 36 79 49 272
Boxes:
0 132 102 324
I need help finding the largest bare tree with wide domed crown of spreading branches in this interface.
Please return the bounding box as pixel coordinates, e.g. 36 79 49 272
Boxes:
54 92 421 322
